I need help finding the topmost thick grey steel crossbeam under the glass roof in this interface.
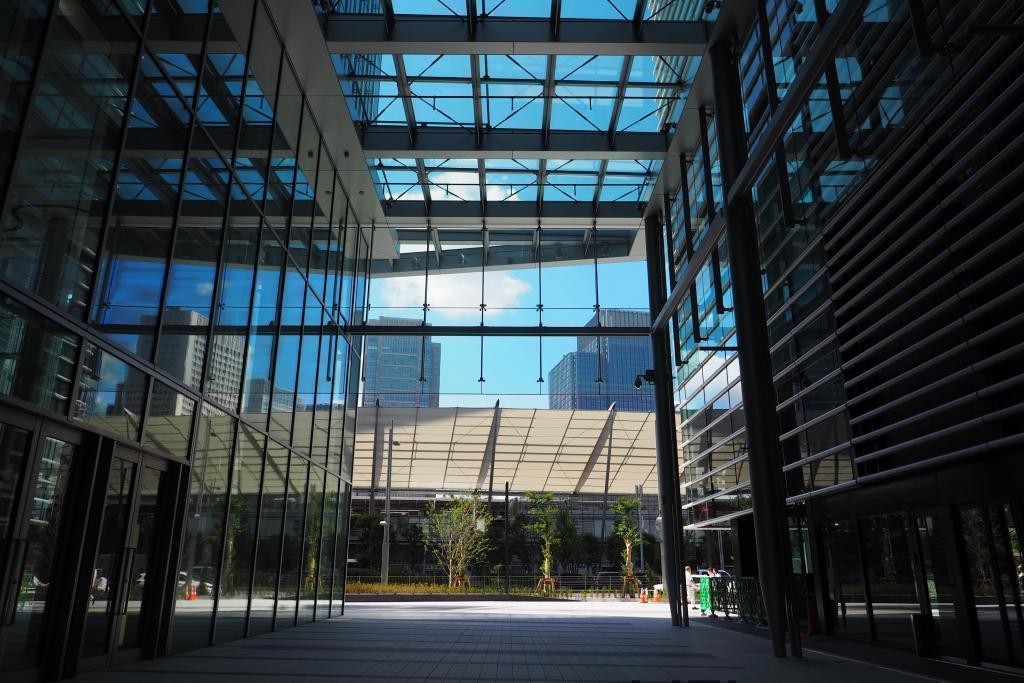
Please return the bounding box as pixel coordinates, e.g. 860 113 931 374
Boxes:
325 14 709 55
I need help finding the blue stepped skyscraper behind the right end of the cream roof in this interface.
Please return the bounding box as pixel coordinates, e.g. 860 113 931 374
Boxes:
548 308 654 412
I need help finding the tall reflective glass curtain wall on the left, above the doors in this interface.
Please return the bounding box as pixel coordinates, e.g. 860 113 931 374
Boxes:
0 0 371 663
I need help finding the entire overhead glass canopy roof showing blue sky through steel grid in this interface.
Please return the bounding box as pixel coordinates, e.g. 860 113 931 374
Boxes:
319 0 717 216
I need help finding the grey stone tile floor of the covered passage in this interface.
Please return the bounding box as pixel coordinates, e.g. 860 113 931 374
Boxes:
79 602 933 683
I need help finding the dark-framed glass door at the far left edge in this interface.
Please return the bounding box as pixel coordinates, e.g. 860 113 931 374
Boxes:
0 411 80 680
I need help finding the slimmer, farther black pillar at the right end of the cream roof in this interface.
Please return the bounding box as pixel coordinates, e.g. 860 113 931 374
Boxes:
644 215 689 626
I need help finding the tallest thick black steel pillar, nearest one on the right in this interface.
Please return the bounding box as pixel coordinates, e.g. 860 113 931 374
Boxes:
708 42 799 657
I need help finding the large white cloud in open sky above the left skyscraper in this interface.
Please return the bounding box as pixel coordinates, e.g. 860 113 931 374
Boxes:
373 271 532 322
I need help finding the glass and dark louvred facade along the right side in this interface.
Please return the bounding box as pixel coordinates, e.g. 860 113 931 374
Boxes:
665 0 1024 666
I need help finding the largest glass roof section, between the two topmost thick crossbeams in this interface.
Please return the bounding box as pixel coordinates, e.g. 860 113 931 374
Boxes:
332 54 698 133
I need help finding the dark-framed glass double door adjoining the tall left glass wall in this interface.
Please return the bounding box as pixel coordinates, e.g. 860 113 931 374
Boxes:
79 446 170 671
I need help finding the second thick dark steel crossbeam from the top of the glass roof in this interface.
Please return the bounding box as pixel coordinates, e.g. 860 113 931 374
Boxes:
361 126 669 160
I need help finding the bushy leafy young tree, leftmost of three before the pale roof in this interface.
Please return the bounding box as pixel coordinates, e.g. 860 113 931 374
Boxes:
423 494 490 586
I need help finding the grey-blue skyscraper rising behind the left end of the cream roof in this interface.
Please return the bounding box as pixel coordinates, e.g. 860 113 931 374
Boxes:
362 316 441 408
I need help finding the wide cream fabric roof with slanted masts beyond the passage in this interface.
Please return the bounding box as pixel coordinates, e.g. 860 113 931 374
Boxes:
353 407 657 494
